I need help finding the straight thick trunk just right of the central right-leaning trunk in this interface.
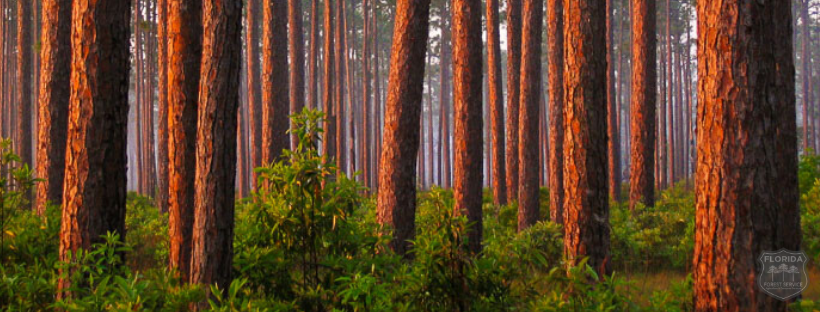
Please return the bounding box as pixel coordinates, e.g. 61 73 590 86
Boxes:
451 0 484 253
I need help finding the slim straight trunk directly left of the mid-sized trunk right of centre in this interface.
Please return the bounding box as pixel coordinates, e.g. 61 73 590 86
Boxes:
506 0 521 199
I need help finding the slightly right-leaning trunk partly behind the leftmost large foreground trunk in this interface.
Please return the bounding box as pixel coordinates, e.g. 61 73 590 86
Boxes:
37 0 71 216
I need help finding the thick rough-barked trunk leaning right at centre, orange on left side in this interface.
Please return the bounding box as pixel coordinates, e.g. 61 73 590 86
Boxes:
378 0 430 255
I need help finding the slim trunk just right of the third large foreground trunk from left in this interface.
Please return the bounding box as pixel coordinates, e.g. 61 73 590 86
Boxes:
245 0 262 180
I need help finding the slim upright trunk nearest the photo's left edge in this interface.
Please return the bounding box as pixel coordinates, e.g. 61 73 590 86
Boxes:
16 0 34 208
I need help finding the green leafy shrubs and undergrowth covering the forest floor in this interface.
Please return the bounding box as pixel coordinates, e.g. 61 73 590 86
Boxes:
0 113 820 311
